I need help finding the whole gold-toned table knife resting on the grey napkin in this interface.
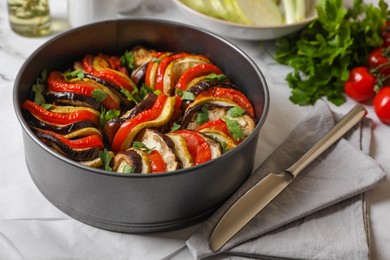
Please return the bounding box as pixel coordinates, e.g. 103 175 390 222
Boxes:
210 105 367 252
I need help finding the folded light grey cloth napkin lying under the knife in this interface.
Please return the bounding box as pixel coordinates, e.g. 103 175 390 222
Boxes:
186 101 386 259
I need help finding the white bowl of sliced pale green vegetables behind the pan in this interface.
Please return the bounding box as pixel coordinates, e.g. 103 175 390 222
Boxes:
173 0 317 40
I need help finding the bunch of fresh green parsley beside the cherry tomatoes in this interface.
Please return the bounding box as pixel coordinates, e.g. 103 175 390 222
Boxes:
275 0 389 105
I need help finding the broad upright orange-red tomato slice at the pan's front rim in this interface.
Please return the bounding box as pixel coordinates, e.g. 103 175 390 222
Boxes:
174 129 211 165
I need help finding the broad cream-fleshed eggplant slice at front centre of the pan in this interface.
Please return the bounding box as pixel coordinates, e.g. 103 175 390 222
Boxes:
137 128 182 171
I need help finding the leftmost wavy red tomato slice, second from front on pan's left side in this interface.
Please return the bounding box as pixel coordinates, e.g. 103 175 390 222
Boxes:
22 100 100 125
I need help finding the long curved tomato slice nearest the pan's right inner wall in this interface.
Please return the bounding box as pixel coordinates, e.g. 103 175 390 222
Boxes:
194 86 255 117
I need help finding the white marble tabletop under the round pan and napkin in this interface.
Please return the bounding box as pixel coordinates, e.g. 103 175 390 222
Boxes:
0 0 390 259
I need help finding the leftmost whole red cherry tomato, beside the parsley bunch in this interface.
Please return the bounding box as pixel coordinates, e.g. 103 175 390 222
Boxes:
344 66 376 102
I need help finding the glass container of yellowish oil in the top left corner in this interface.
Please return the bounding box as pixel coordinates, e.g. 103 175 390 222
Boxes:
7 0 51 37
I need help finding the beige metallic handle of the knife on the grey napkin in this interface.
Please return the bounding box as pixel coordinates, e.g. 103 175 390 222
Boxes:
286 105 367 177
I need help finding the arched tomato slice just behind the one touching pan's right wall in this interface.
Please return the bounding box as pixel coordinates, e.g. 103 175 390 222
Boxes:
175 63 223 91
